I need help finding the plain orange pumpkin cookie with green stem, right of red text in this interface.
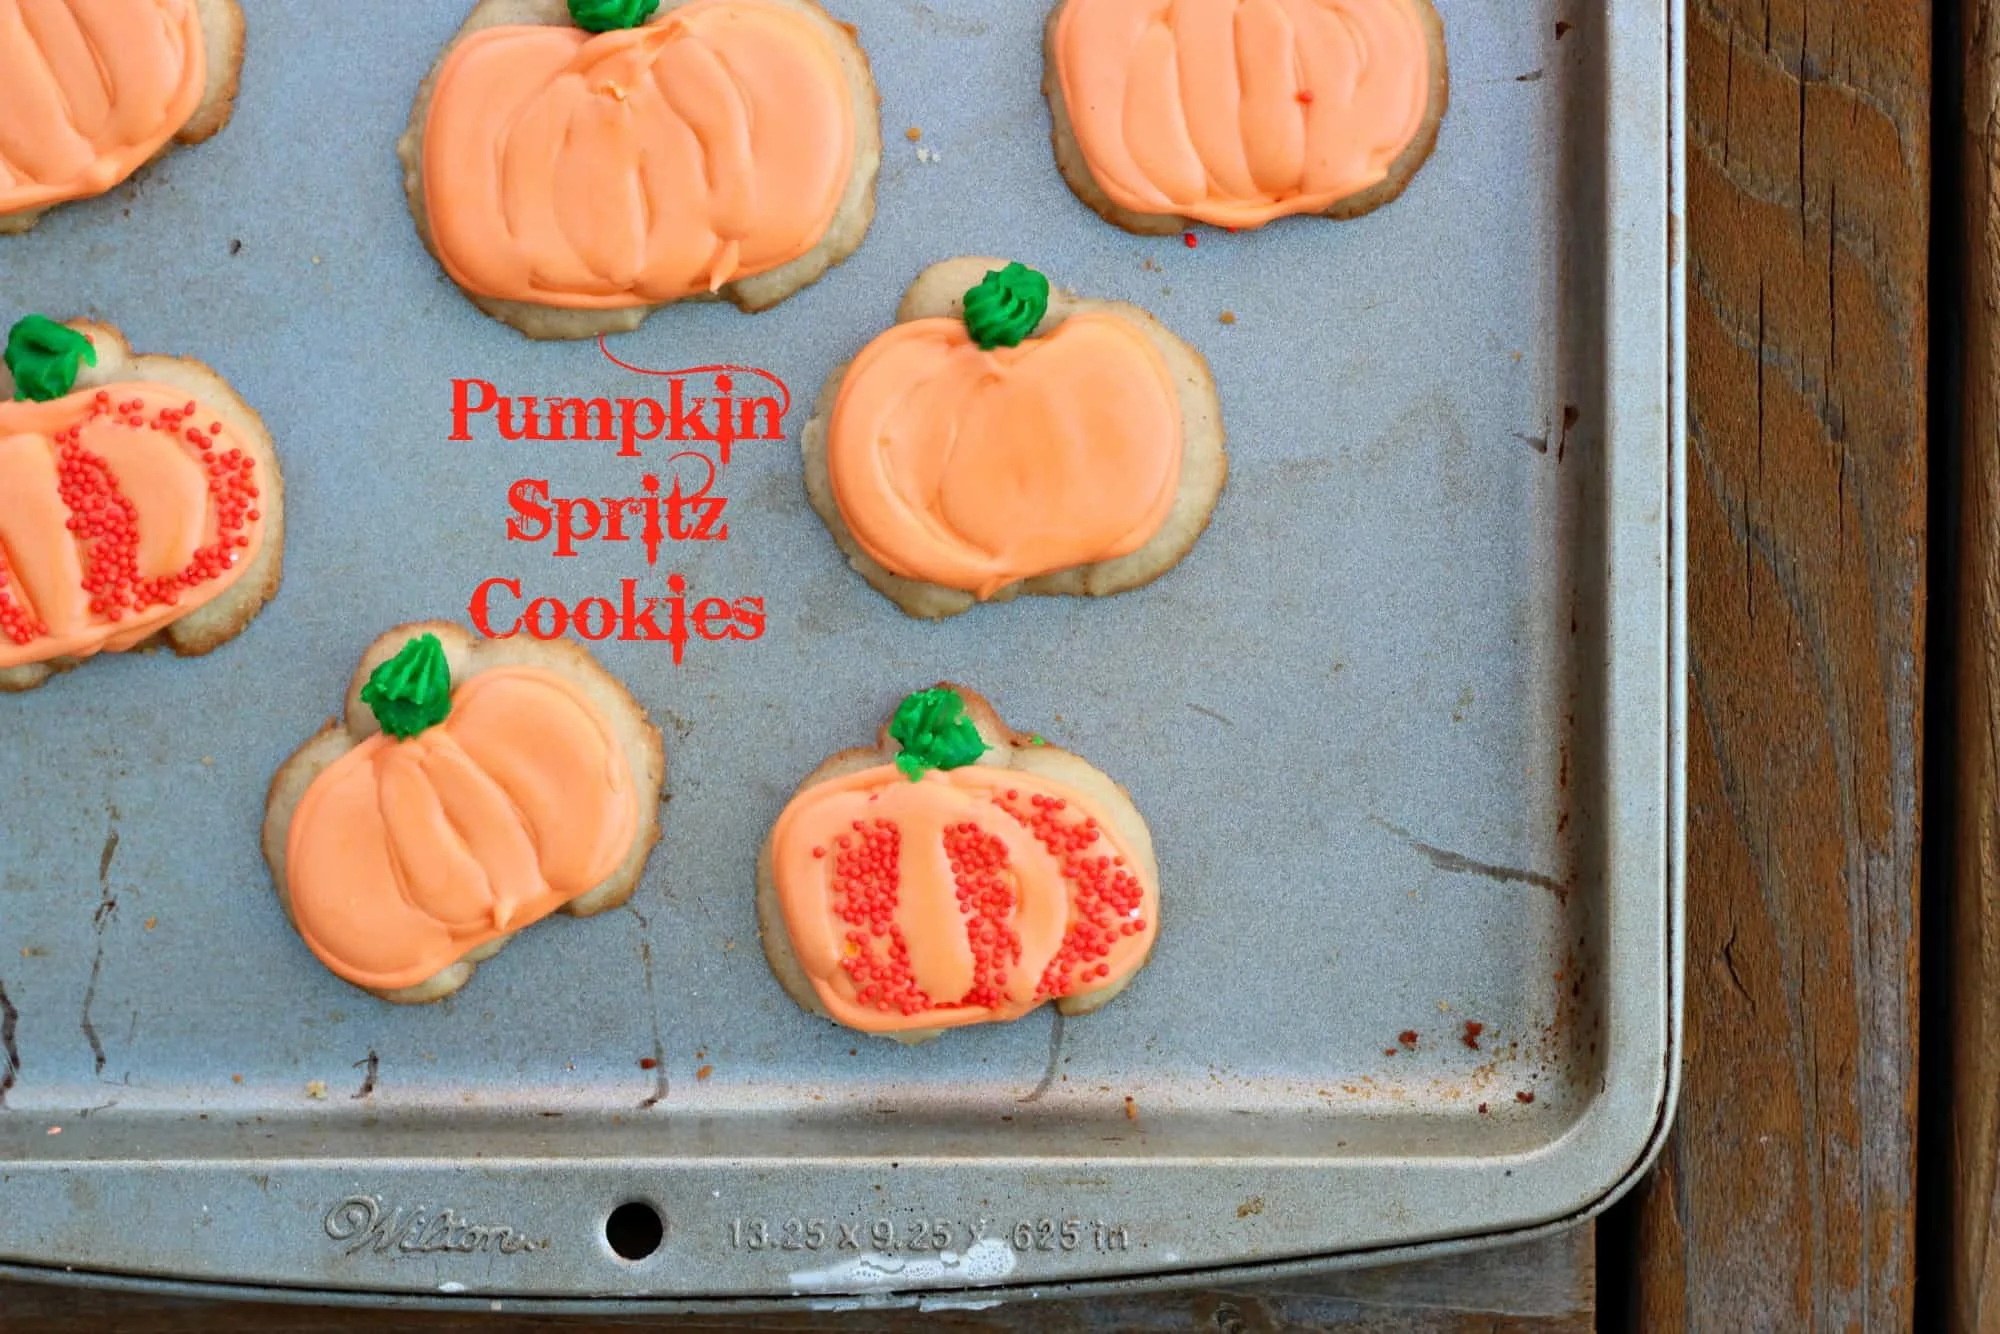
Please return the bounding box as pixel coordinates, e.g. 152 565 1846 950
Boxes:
802 258 1228 618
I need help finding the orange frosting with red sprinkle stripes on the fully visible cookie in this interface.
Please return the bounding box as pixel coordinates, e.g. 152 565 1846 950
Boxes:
770 764 1160 1034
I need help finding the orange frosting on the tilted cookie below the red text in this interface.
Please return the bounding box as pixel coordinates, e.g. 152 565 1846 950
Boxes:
284 666 640 990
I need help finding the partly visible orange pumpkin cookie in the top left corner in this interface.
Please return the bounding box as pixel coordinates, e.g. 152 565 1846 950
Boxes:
0 0 244 232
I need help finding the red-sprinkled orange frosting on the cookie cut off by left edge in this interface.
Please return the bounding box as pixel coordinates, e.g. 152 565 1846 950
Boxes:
0 382 266 668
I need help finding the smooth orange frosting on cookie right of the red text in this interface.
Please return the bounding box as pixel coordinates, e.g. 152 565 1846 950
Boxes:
826 312 1184 598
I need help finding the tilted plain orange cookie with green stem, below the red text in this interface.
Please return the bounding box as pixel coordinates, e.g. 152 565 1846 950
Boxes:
264 622 666 1004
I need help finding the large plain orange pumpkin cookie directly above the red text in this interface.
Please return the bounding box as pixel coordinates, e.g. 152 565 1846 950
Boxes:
398 0 882 338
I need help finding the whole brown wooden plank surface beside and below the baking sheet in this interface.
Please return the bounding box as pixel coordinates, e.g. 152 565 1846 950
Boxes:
0 0 1944 1334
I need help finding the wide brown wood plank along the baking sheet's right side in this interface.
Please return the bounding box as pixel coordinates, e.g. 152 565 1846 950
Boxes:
1628 0 1932 1330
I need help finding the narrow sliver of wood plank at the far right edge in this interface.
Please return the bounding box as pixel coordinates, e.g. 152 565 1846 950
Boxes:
1938 0 2000 1334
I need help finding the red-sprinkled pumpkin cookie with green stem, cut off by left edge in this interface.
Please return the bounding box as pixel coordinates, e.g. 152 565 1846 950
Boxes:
0 316 284 690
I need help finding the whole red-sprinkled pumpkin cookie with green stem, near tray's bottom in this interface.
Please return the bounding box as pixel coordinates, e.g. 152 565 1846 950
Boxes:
756 684 1160 1042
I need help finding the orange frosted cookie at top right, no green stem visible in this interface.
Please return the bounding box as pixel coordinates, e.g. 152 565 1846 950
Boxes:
1042 0 1448 232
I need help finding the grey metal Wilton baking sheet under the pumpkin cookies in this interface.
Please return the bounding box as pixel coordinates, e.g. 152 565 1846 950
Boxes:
0 0 1684 1308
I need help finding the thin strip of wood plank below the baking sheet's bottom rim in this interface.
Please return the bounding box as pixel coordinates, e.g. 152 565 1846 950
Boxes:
0 1226 1596 1334
